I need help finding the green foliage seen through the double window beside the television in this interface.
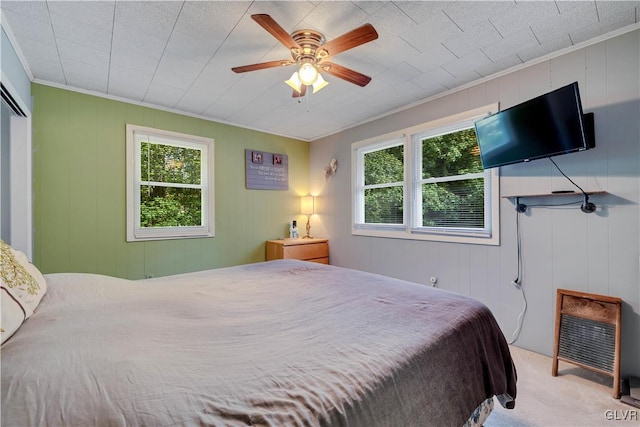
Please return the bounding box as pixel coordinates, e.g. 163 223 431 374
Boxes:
364 128 484 228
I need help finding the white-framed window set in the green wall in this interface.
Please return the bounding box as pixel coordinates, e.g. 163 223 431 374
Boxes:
127 125 215 241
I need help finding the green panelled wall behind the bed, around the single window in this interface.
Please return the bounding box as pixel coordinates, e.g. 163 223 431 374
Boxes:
32 84 309 279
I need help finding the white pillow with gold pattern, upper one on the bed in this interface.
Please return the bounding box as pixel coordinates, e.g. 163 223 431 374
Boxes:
0 240 47 318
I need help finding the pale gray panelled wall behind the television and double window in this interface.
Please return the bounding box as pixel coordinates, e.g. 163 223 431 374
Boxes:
310 30 640 376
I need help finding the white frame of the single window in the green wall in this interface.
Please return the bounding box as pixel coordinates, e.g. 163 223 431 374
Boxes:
126 124 215 242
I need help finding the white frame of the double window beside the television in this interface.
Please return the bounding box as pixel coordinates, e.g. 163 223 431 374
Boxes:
351 103 500 245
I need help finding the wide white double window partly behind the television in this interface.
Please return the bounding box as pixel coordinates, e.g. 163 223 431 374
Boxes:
352 105 499 245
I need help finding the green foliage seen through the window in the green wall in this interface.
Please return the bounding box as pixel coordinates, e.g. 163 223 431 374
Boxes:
140 142 202 227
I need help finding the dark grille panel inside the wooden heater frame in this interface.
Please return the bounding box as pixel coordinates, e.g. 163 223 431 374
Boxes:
558 314 616 373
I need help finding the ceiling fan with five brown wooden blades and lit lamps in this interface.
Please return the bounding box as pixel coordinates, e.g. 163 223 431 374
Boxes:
231 14 378 97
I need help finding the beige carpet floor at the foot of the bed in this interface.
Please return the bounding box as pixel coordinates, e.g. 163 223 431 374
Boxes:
484 346 640 427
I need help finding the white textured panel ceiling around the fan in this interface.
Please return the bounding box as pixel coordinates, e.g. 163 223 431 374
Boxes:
0 0 640 140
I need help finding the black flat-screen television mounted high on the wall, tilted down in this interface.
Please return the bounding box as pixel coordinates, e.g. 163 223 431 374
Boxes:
475 82 595 169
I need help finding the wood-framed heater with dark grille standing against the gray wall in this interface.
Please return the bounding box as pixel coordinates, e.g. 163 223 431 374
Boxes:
551 289 622 399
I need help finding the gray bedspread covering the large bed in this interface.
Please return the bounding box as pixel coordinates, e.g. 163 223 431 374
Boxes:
1 260 516 427
